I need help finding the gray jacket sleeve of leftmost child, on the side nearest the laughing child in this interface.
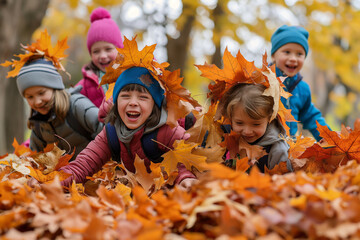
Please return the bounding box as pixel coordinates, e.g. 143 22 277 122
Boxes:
70 86 104 138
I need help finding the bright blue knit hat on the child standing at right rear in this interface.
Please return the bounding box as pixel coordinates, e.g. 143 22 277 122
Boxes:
271 25 309 56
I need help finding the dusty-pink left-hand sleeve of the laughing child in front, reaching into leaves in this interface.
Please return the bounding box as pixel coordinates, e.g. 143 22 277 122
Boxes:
59 127 111 186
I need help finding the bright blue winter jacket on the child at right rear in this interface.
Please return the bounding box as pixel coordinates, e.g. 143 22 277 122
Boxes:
276 68 330 141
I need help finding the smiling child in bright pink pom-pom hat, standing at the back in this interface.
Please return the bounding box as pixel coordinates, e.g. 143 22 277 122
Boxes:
76 7 123 108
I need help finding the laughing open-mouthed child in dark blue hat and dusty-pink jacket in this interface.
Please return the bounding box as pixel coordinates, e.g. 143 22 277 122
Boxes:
60 67 195 186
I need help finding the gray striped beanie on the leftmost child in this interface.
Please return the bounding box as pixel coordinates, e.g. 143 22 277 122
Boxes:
16 58 65 96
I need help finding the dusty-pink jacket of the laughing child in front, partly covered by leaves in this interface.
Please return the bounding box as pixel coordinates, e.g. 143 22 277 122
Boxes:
59 125 195 186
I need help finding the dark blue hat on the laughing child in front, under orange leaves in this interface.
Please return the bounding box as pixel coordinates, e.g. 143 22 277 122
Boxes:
113 67 164 108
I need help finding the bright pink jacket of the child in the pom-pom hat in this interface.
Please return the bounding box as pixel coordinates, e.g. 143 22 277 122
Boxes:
76 66 105 107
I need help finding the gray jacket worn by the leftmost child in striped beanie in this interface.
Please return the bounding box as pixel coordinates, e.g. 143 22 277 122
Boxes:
29 86 104 159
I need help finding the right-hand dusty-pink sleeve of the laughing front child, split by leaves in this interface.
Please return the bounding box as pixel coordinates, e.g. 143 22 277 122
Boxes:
157 125 196 184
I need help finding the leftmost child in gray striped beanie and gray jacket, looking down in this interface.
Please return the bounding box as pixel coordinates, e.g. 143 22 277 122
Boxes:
17 58 103 159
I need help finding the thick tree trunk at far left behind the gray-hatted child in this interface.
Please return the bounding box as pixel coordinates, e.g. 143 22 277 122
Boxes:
0 0 49 155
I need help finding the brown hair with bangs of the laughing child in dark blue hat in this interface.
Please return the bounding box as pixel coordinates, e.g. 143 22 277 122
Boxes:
105 84 161 127
